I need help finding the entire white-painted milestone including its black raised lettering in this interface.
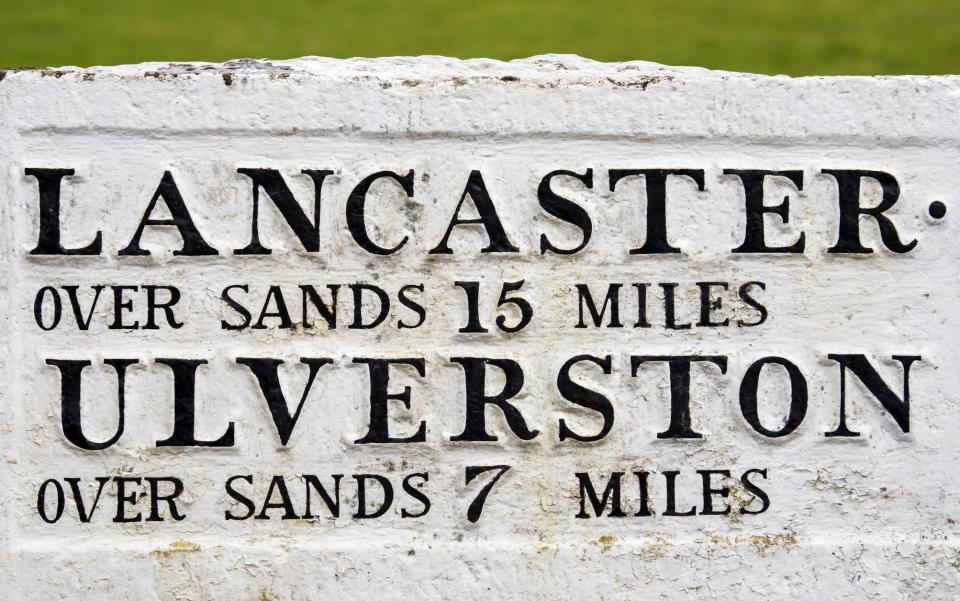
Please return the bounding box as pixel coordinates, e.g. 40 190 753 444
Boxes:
0 56 960 601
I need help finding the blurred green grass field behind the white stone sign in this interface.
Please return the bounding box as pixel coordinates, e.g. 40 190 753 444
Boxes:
0 0 960 75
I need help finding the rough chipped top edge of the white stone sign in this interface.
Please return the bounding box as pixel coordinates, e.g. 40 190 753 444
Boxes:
0 54 960 82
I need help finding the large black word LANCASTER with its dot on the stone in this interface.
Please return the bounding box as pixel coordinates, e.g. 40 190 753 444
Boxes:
24 167 916 257
